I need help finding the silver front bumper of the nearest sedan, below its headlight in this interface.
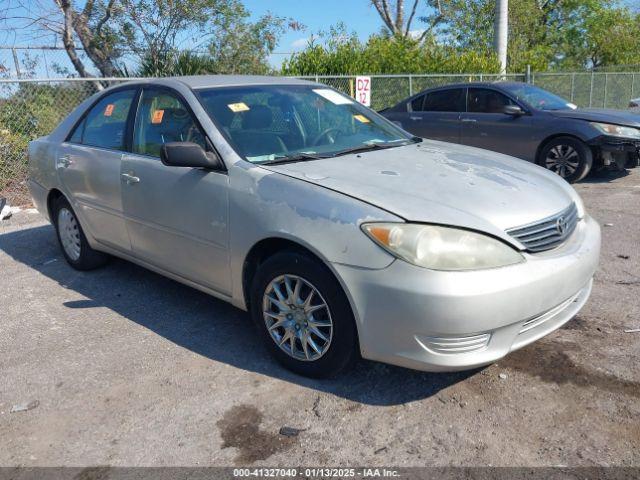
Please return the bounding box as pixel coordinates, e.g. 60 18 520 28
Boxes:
334 216 600 371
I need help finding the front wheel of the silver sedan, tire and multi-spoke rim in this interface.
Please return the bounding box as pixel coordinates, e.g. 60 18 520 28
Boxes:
250 252 358 378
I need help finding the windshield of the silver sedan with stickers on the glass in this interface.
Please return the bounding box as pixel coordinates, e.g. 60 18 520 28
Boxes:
198 85 414 163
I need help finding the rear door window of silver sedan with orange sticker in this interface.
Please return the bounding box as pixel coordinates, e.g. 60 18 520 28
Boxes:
69 90 135 150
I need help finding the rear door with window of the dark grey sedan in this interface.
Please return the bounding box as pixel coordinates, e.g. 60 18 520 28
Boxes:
403 88 465 143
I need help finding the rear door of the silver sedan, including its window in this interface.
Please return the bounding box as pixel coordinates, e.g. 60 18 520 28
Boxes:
56 88 136 252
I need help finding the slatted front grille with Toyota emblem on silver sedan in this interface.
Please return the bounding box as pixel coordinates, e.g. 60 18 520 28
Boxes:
507 203 578 252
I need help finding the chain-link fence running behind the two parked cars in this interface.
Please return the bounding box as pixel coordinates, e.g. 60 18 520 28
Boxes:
0 72 640 205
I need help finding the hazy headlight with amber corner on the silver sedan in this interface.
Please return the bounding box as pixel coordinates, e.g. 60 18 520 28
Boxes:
362 223 524 270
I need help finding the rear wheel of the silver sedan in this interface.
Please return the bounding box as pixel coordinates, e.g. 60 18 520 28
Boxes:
53 197 109 271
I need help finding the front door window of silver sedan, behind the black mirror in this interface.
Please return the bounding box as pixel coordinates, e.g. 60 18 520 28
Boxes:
133 90 207 157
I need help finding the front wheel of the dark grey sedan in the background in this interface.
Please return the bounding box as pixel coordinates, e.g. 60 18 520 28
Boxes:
538 137 593 183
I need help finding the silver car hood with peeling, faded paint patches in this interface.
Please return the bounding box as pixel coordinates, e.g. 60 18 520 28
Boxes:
265 140 575 241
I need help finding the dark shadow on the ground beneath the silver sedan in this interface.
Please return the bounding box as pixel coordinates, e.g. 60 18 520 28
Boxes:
0 226 477 405
